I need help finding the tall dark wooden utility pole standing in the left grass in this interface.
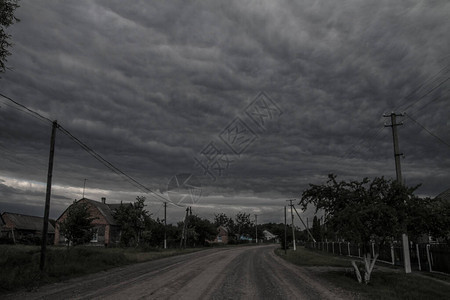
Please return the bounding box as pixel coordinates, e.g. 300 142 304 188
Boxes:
39 121 58 271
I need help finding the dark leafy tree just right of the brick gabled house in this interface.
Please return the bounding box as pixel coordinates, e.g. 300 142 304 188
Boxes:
114 196 151 247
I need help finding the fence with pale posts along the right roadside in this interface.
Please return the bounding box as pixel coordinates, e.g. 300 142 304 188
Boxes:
305 242 450 274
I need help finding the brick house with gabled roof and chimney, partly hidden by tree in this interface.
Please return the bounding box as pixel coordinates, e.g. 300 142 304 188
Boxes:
54 198 125 247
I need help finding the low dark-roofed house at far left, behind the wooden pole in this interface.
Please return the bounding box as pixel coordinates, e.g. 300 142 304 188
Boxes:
1 212 55 244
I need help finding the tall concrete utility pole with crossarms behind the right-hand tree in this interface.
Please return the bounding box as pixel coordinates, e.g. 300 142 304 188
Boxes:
383 112 411 273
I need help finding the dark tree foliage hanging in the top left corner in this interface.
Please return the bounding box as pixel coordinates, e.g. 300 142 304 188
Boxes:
0 0 19 72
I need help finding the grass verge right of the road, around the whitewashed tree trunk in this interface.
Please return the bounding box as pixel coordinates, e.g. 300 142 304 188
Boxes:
275 247 450 299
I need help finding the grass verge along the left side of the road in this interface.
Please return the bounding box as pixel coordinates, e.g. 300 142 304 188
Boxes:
0 245 201 293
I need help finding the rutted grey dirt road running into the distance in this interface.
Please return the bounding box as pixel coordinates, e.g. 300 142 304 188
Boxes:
6 246 348 299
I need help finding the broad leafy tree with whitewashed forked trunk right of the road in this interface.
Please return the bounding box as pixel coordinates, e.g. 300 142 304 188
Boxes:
300 174 446 283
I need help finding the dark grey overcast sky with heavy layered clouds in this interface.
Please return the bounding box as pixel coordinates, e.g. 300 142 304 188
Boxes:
0 0 450 222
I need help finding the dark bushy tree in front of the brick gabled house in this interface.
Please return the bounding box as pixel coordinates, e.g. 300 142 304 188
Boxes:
59 202 95 246
